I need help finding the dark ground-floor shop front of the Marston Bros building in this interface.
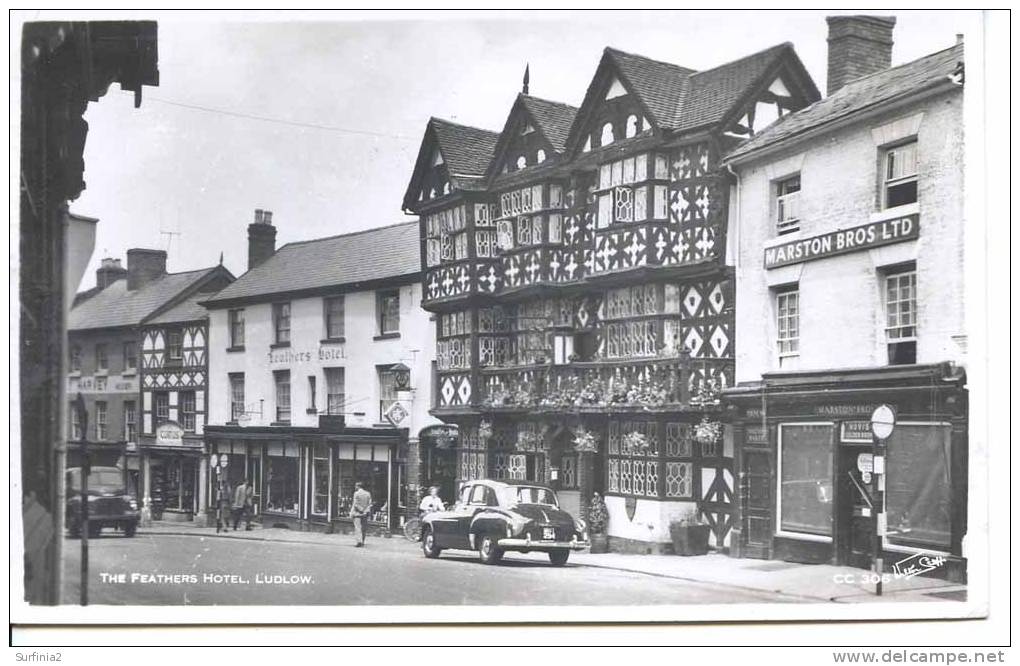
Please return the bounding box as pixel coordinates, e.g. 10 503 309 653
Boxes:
723 364 967 580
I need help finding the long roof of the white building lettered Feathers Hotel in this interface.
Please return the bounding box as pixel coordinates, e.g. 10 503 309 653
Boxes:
207 220 421 304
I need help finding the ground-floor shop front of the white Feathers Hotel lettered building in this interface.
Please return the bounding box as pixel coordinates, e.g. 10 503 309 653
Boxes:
206 424 407 532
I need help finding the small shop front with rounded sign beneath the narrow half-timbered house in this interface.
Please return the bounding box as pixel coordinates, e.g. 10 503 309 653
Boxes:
139 421 205 522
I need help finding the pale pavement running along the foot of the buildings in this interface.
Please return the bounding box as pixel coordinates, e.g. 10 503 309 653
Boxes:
129 522 967 603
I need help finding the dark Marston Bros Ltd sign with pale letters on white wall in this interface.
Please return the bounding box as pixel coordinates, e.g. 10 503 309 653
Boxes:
765 215 921 268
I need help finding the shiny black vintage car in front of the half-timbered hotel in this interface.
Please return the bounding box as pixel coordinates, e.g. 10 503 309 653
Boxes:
421 480 590 566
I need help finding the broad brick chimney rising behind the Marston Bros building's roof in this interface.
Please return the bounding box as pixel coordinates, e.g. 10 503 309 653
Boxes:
825 15 896 95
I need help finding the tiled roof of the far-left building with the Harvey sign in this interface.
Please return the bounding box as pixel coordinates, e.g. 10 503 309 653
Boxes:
67 266 218 330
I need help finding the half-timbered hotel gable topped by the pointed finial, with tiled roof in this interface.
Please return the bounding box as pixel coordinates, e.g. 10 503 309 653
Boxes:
490 94 577 177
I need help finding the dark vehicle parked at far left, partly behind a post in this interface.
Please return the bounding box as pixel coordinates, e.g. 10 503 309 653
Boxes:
64 466 139 539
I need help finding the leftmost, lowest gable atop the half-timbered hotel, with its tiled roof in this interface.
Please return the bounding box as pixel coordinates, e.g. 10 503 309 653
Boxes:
404 118 500 211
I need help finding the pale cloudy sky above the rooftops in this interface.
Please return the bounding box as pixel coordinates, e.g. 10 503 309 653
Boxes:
65 10 980 289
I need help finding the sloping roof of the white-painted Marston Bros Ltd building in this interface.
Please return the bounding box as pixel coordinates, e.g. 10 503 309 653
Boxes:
726 44 963 160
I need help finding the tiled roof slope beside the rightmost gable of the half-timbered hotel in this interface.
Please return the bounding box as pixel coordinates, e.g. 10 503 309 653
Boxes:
669 42 797 131
